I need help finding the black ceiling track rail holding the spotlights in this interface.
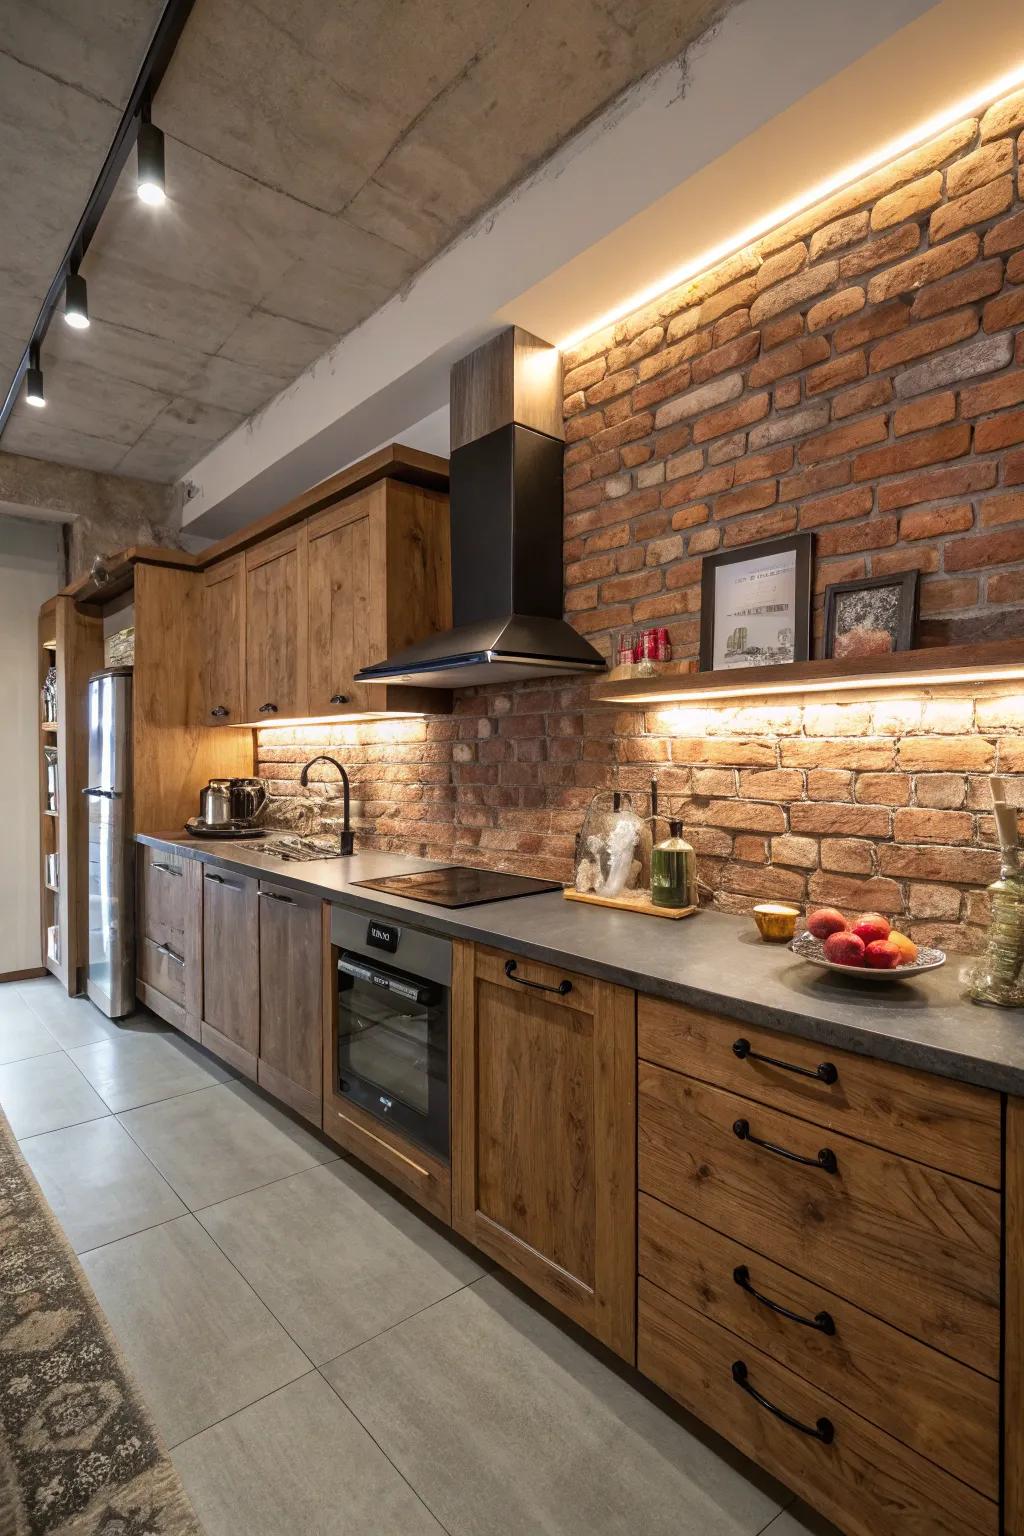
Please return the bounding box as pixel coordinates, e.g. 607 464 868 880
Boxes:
0 0 195 433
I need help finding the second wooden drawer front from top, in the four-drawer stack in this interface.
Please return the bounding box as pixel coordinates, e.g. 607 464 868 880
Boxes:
639 1061 999 1376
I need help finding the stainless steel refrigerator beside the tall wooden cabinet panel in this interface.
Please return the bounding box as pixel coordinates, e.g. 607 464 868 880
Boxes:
81 667 135 1018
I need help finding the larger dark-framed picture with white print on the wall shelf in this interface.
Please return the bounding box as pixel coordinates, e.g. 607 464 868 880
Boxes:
700 533 814 671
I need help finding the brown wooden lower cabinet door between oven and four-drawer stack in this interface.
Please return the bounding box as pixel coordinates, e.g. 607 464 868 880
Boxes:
451 943 637 1359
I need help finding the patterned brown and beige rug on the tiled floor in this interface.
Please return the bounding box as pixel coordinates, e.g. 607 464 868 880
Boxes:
0 1111 201 1536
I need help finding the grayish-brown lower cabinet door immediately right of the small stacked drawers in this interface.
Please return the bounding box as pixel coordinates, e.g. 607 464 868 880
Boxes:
201 868 259 1078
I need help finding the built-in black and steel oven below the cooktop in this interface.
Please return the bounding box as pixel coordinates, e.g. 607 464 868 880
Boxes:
332 906 451 1160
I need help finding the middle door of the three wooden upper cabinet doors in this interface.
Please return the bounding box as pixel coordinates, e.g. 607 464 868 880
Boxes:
246 525 307 725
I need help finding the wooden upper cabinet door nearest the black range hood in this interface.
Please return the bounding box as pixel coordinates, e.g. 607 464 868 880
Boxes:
309 487 384 714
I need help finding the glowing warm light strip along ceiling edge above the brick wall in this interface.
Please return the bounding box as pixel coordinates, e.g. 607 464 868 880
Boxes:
557 61 1024 352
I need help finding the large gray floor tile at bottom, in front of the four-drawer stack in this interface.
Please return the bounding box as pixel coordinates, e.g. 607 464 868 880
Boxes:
324 1276 783 1536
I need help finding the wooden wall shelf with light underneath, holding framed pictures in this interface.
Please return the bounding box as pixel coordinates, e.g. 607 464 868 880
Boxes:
591 639 1024 705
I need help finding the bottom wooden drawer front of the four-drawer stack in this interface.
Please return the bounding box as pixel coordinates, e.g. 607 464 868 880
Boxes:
637 1279 998 1536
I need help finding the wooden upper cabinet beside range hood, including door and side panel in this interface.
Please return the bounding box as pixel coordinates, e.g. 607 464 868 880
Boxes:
306 481 451 714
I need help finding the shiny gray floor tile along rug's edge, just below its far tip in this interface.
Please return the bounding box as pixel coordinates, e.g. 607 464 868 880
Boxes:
21 1115 184 1253
